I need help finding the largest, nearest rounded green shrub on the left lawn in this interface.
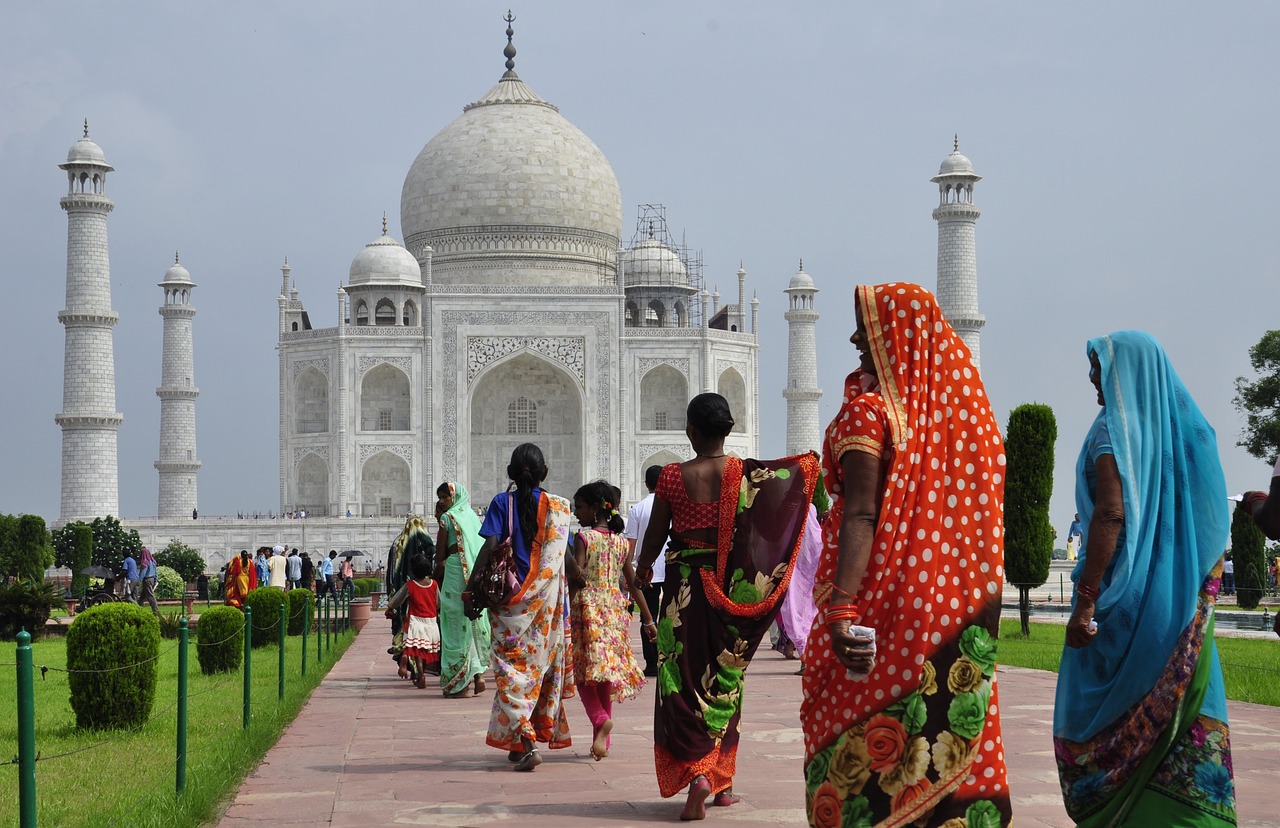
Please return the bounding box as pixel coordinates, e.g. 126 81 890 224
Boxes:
67 603 160 729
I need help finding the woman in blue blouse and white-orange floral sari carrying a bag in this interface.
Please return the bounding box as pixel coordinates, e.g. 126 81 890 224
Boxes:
467 443 577 770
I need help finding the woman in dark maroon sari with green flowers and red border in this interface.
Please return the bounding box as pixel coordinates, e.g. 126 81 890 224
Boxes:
639 394 818 820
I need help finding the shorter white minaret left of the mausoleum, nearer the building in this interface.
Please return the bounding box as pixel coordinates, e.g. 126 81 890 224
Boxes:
155 253 200 518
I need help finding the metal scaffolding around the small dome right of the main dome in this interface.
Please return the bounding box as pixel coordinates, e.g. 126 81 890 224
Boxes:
618 203 705 328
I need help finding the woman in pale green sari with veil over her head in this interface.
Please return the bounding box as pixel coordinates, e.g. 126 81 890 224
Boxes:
435 482 489 699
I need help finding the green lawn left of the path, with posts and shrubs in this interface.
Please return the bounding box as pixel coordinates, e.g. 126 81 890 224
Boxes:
0 624 353 827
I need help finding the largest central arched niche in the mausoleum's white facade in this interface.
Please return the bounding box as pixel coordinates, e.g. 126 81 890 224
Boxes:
471 352 585 504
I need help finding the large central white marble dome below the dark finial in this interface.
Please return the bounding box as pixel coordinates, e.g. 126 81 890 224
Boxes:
401 70 622 284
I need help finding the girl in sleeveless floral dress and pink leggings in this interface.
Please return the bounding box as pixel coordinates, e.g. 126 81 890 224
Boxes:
570 480 658 761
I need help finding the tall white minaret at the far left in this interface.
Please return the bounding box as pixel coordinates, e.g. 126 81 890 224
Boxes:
54 120 124 522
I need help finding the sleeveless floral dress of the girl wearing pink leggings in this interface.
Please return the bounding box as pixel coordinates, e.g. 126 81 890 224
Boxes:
572 529 644 701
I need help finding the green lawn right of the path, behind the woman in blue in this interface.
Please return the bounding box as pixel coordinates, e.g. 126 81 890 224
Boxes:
1000 618 1280 706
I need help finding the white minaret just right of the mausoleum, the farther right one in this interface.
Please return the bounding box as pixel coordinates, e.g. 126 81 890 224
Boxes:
782 260 822 454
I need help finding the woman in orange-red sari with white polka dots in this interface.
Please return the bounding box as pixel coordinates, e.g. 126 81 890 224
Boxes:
800 283 1010 828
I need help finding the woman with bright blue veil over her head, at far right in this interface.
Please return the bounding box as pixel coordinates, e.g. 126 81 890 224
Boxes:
1053 330 1235 827
